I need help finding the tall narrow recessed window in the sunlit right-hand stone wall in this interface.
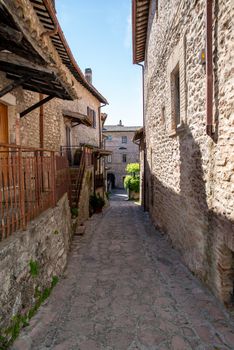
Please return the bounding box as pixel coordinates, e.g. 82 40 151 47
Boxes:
171 64 181 129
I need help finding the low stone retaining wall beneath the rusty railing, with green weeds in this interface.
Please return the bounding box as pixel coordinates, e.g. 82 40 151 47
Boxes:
0 194 71 329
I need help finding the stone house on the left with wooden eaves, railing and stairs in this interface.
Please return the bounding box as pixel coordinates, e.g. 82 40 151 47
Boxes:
0 0 107 336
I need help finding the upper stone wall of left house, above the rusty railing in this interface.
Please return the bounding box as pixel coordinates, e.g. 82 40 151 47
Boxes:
0 73 100 151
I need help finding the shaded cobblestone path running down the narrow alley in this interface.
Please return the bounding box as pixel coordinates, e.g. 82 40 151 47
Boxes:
13 191 234 350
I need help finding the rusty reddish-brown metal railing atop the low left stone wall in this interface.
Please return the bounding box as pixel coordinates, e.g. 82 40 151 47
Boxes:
0 144 70 241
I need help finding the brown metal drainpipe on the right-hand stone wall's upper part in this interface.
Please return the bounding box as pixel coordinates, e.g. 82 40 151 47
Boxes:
206 0 213 136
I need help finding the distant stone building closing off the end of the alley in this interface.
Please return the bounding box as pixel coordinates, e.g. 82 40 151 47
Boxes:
103 120 139 188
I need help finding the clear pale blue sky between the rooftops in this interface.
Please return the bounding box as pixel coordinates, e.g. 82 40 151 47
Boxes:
56 0 142 125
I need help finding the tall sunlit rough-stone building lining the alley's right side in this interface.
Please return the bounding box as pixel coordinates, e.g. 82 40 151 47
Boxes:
132 0 234 305
